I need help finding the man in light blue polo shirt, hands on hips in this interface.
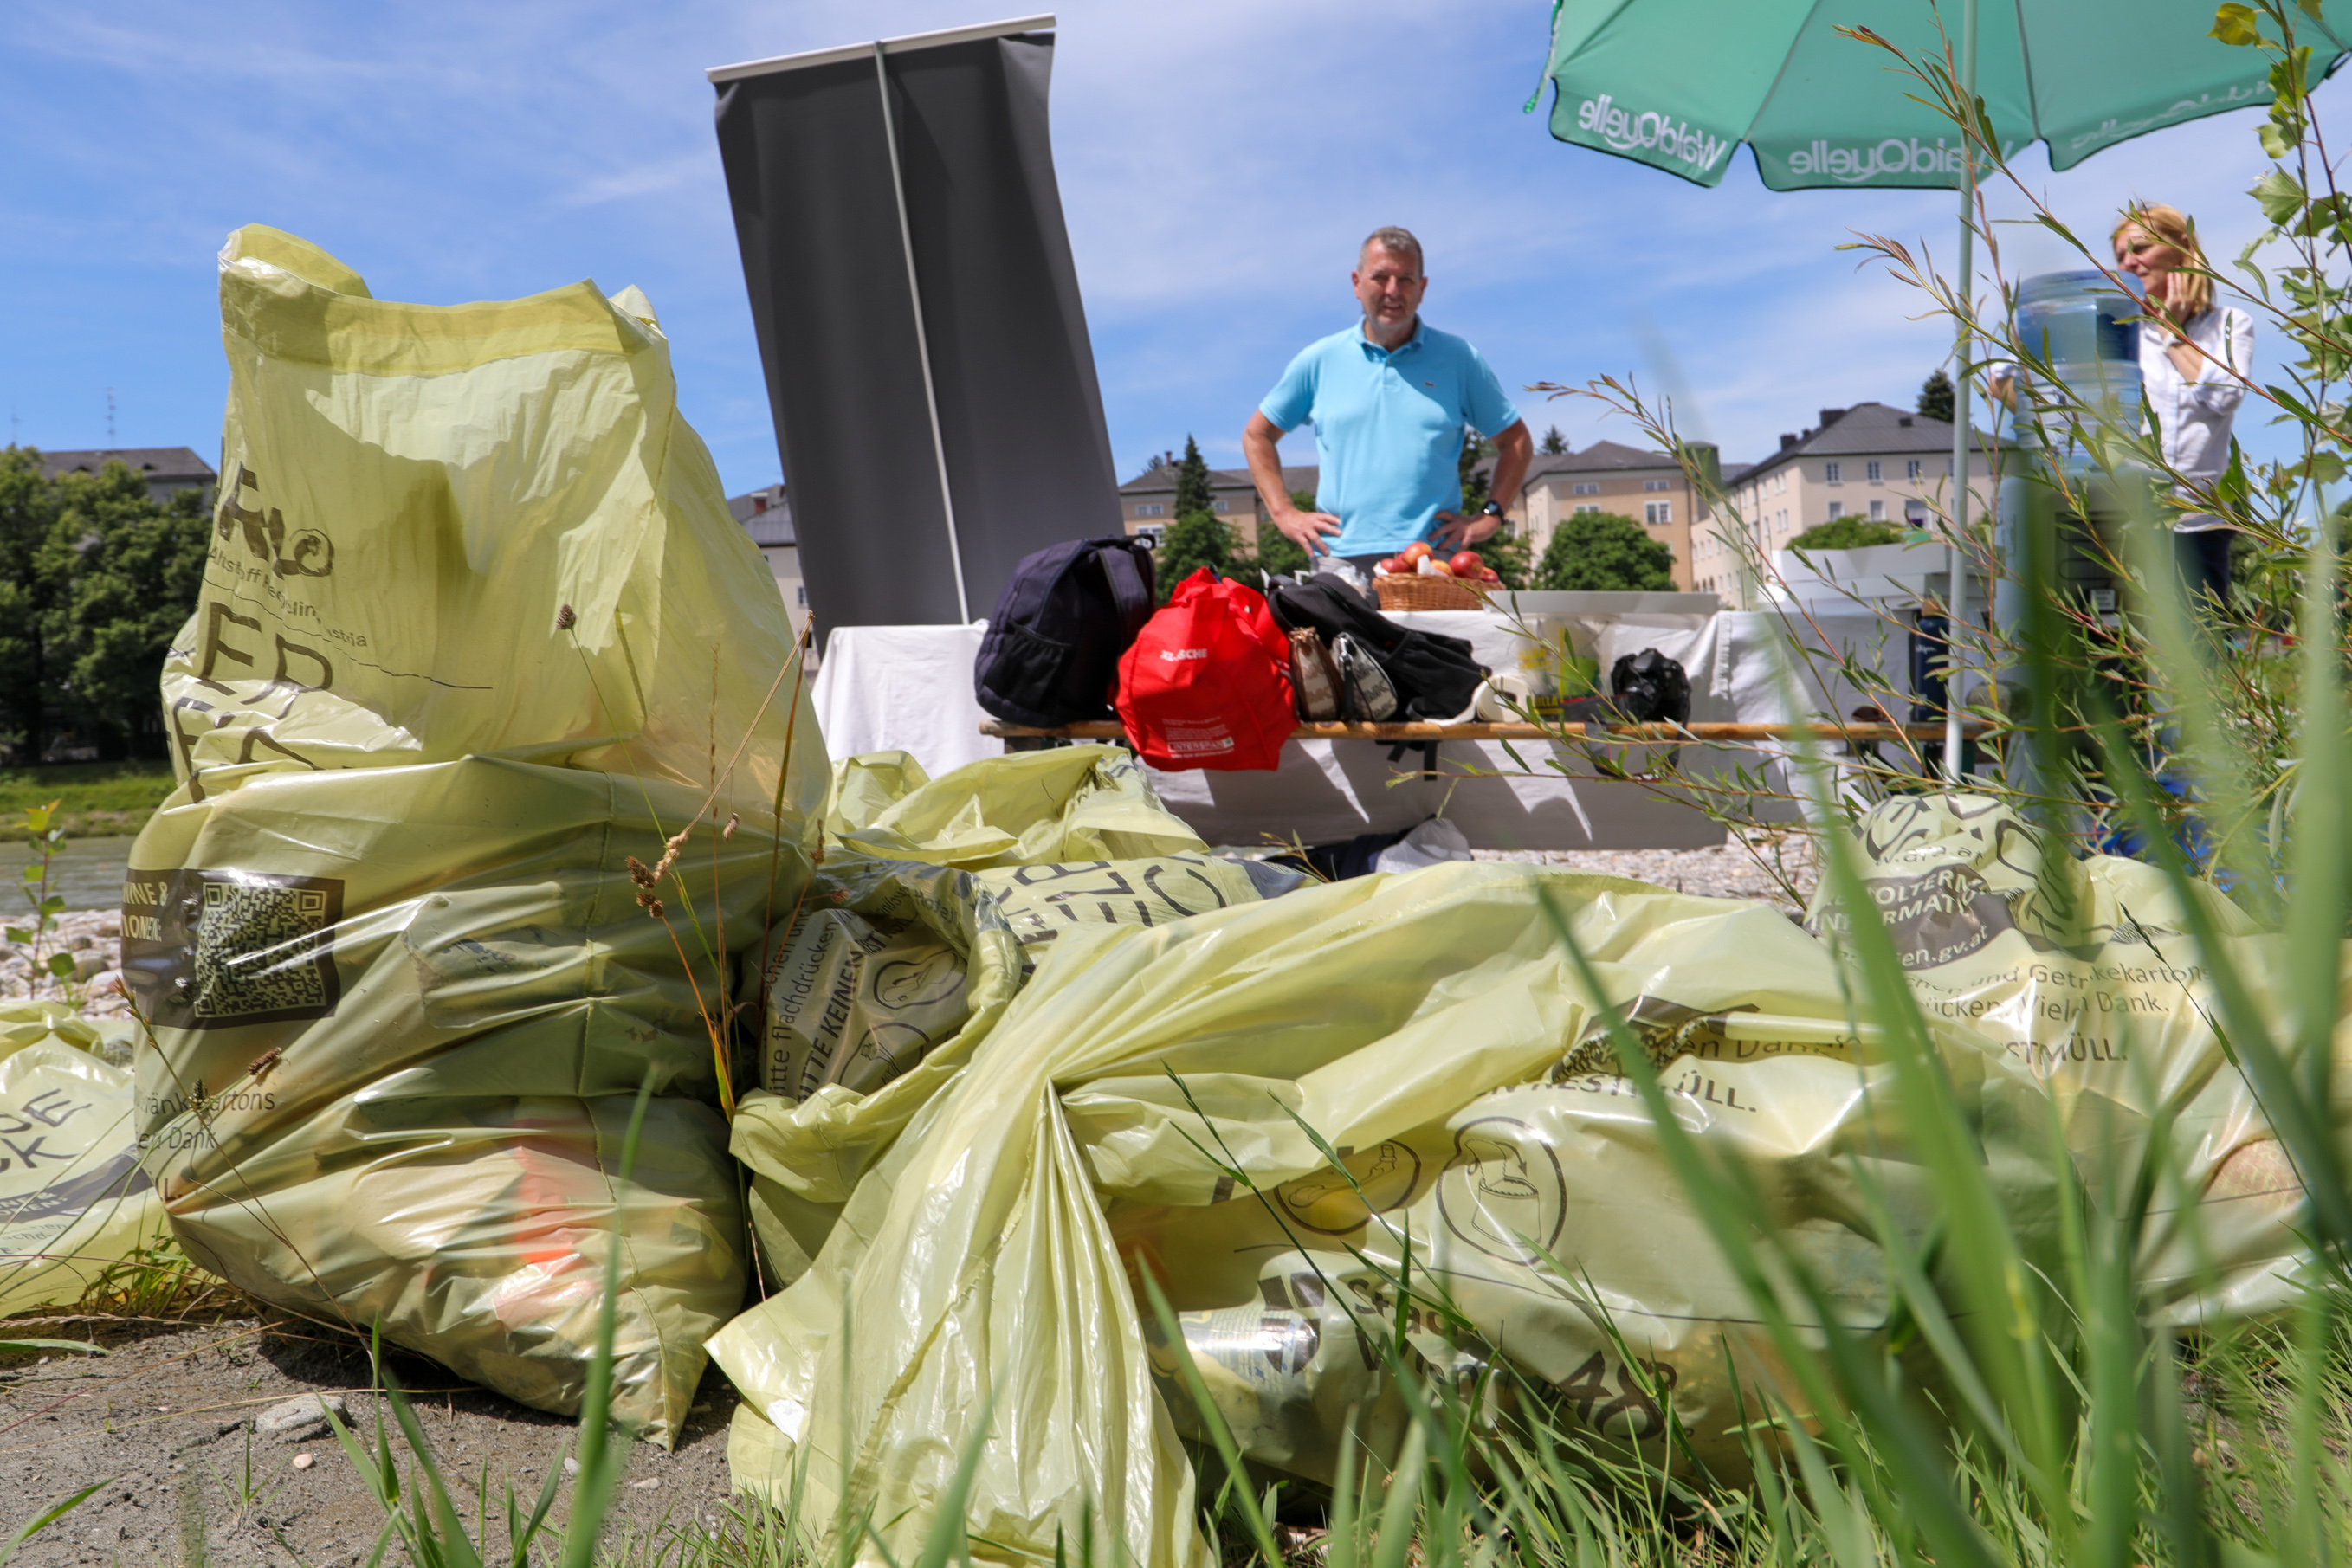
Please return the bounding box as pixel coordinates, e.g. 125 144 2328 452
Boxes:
1242 228 1536 576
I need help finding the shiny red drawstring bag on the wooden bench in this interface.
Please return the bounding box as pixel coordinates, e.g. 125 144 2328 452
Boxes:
1117 566 1298 773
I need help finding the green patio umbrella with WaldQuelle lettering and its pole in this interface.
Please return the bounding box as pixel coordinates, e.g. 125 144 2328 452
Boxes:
1545 0 2345 778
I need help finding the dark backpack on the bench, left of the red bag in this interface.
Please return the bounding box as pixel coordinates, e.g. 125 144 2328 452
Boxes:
972 536 1155 729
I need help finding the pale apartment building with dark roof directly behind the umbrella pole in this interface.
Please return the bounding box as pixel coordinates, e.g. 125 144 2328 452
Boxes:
1677 402 2008 609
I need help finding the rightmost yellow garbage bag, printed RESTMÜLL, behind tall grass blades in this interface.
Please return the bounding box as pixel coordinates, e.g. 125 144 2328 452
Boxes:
1811 795 2314 1326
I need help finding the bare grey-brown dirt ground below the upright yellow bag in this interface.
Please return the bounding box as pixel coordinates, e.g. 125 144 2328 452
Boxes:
0 1316 736 1568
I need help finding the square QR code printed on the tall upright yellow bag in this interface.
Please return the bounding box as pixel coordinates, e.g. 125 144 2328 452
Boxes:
193 877 344 1023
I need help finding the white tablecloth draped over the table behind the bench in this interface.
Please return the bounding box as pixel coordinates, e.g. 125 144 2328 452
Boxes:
811 611 1871 849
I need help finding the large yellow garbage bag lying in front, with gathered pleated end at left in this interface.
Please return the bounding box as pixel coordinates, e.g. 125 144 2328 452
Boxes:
713 862 2051 1568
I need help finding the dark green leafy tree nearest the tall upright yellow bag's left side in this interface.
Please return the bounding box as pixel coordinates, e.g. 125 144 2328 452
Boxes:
49 463 210 759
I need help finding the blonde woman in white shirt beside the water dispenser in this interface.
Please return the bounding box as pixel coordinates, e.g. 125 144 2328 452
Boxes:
1990 203 2253 602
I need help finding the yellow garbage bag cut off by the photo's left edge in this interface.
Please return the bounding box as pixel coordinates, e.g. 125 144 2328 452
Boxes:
0 1002 167 1314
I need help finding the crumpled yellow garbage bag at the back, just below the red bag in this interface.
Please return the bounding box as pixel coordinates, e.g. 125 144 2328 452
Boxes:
828 745 1206 870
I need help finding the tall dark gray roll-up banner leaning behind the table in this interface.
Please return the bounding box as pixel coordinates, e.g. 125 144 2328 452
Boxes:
708 16 1120 635
